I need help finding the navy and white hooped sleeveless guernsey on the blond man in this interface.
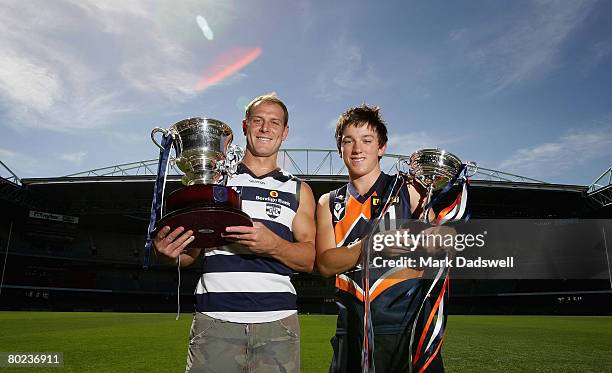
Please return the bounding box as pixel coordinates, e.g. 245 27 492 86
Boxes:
195 163 301 323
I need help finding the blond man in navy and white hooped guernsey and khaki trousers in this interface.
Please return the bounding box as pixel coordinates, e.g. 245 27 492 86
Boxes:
154 94 315 373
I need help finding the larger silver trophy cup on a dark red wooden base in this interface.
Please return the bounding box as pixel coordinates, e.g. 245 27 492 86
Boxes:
151 118 253 248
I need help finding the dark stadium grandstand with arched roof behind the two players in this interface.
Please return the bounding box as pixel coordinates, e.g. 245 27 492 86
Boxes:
0 149 612 314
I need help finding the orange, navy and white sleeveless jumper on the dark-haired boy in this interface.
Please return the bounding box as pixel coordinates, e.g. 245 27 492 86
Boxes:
329 173 443 373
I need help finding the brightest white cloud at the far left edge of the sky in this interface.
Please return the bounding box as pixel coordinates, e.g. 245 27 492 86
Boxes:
0 2 124 131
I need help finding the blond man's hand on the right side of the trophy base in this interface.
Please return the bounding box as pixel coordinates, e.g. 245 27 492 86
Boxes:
222 222 281 255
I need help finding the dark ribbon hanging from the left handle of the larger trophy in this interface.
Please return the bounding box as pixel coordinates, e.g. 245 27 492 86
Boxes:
143 129 173 269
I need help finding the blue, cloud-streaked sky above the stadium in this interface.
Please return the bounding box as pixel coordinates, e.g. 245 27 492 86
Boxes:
0 0 612 185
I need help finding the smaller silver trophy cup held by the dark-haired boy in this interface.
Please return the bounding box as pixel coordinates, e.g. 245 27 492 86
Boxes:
408 149 476 220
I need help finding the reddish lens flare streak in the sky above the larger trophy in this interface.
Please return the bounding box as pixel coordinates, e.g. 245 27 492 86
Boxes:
196 47 261 91
